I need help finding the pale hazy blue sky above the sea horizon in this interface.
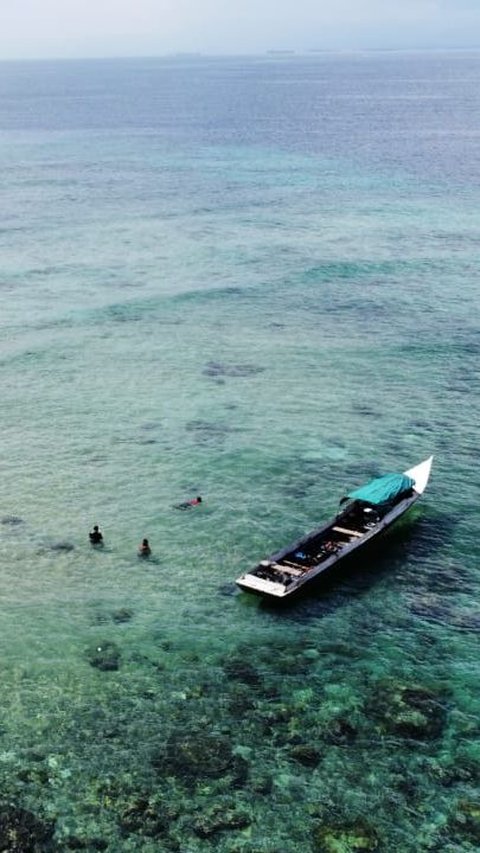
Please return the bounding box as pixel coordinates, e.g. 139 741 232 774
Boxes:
0 0 480 59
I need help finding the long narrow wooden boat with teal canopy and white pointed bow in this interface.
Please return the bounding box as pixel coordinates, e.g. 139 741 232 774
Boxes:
236 456 433 599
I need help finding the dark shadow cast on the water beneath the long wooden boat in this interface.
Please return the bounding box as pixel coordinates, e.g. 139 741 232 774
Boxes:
253 508 457 621
